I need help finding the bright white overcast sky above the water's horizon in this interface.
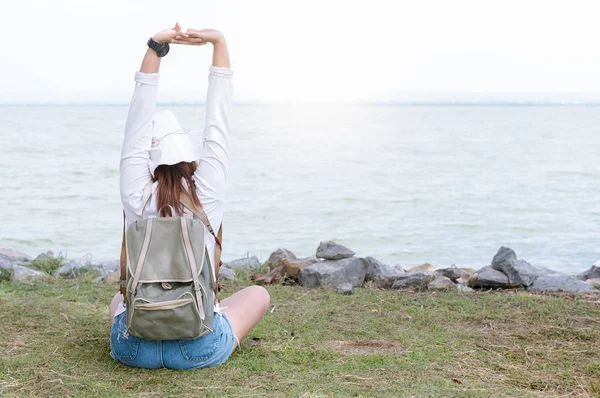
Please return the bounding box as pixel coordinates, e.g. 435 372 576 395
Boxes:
0 0 600 104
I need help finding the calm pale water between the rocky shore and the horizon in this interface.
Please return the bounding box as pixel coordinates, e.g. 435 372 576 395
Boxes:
0 105 600 273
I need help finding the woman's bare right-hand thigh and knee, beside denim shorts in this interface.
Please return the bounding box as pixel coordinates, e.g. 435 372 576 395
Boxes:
219 286 271 349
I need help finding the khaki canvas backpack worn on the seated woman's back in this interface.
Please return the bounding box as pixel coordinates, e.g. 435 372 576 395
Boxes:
121 184 223 340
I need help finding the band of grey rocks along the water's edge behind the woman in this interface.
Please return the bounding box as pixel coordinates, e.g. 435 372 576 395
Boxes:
0 241 600 294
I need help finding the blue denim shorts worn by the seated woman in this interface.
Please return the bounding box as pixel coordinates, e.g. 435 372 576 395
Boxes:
110 312 235 369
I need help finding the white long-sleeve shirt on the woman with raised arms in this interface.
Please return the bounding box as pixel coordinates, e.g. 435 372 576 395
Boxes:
120 66 233 290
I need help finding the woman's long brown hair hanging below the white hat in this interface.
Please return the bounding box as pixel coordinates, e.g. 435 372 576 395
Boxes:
154 162 200 217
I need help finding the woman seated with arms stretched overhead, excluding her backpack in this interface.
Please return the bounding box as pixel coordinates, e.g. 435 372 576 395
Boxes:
110 23 269 369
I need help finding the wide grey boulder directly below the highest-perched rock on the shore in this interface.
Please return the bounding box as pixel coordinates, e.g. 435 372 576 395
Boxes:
298 257 367 288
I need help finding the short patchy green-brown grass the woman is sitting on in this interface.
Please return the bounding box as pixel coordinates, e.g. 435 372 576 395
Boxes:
0 276 600 397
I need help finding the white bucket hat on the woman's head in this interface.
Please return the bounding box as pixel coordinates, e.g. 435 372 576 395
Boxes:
148 110 202 176
